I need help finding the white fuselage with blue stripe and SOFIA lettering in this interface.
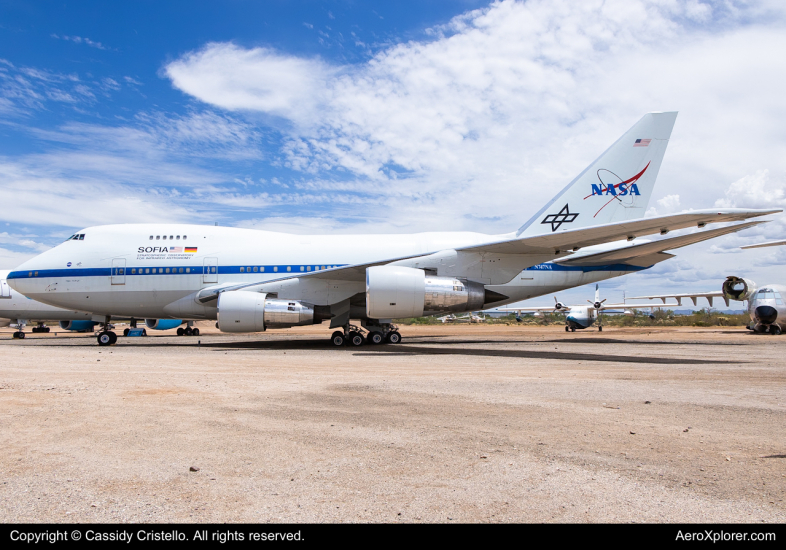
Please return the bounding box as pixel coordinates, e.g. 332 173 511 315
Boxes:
9 224 644 319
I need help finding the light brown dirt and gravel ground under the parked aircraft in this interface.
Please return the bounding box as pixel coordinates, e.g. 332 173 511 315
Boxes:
0 323 786 523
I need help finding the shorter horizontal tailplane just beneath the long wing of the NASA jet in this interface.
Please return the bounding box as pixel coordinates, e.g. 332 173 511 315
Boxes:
557 221 767 267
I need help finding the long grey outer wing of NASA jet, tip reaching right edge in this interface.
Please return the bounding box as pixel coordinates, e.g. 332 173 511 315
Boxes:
457 208 783 256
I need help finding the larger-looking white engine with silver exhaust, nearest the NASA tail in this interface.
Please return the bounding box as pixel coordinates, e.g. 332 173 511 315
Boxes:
366 265 484 319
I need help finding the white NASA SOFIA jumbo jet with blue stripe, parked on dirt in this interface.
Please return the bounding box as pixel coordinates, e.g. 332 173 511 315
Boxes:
8 112 780 345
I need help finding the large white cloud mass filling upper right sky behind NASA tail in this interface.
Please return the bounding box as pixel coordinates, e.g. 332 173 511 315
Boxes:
164 0 786 235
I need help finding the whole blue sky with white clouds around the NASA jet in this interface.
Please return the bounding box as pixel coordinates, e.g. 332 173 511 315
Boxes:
0 0 786 308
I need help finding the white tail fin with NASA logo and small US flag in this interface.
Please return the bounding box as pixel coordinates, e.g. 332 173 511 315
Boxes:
517 112 677 237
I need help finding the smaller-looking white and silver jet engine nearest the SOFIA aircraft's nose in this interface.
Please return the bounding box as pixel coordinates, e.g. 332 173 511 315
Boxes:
218 291 332 332
